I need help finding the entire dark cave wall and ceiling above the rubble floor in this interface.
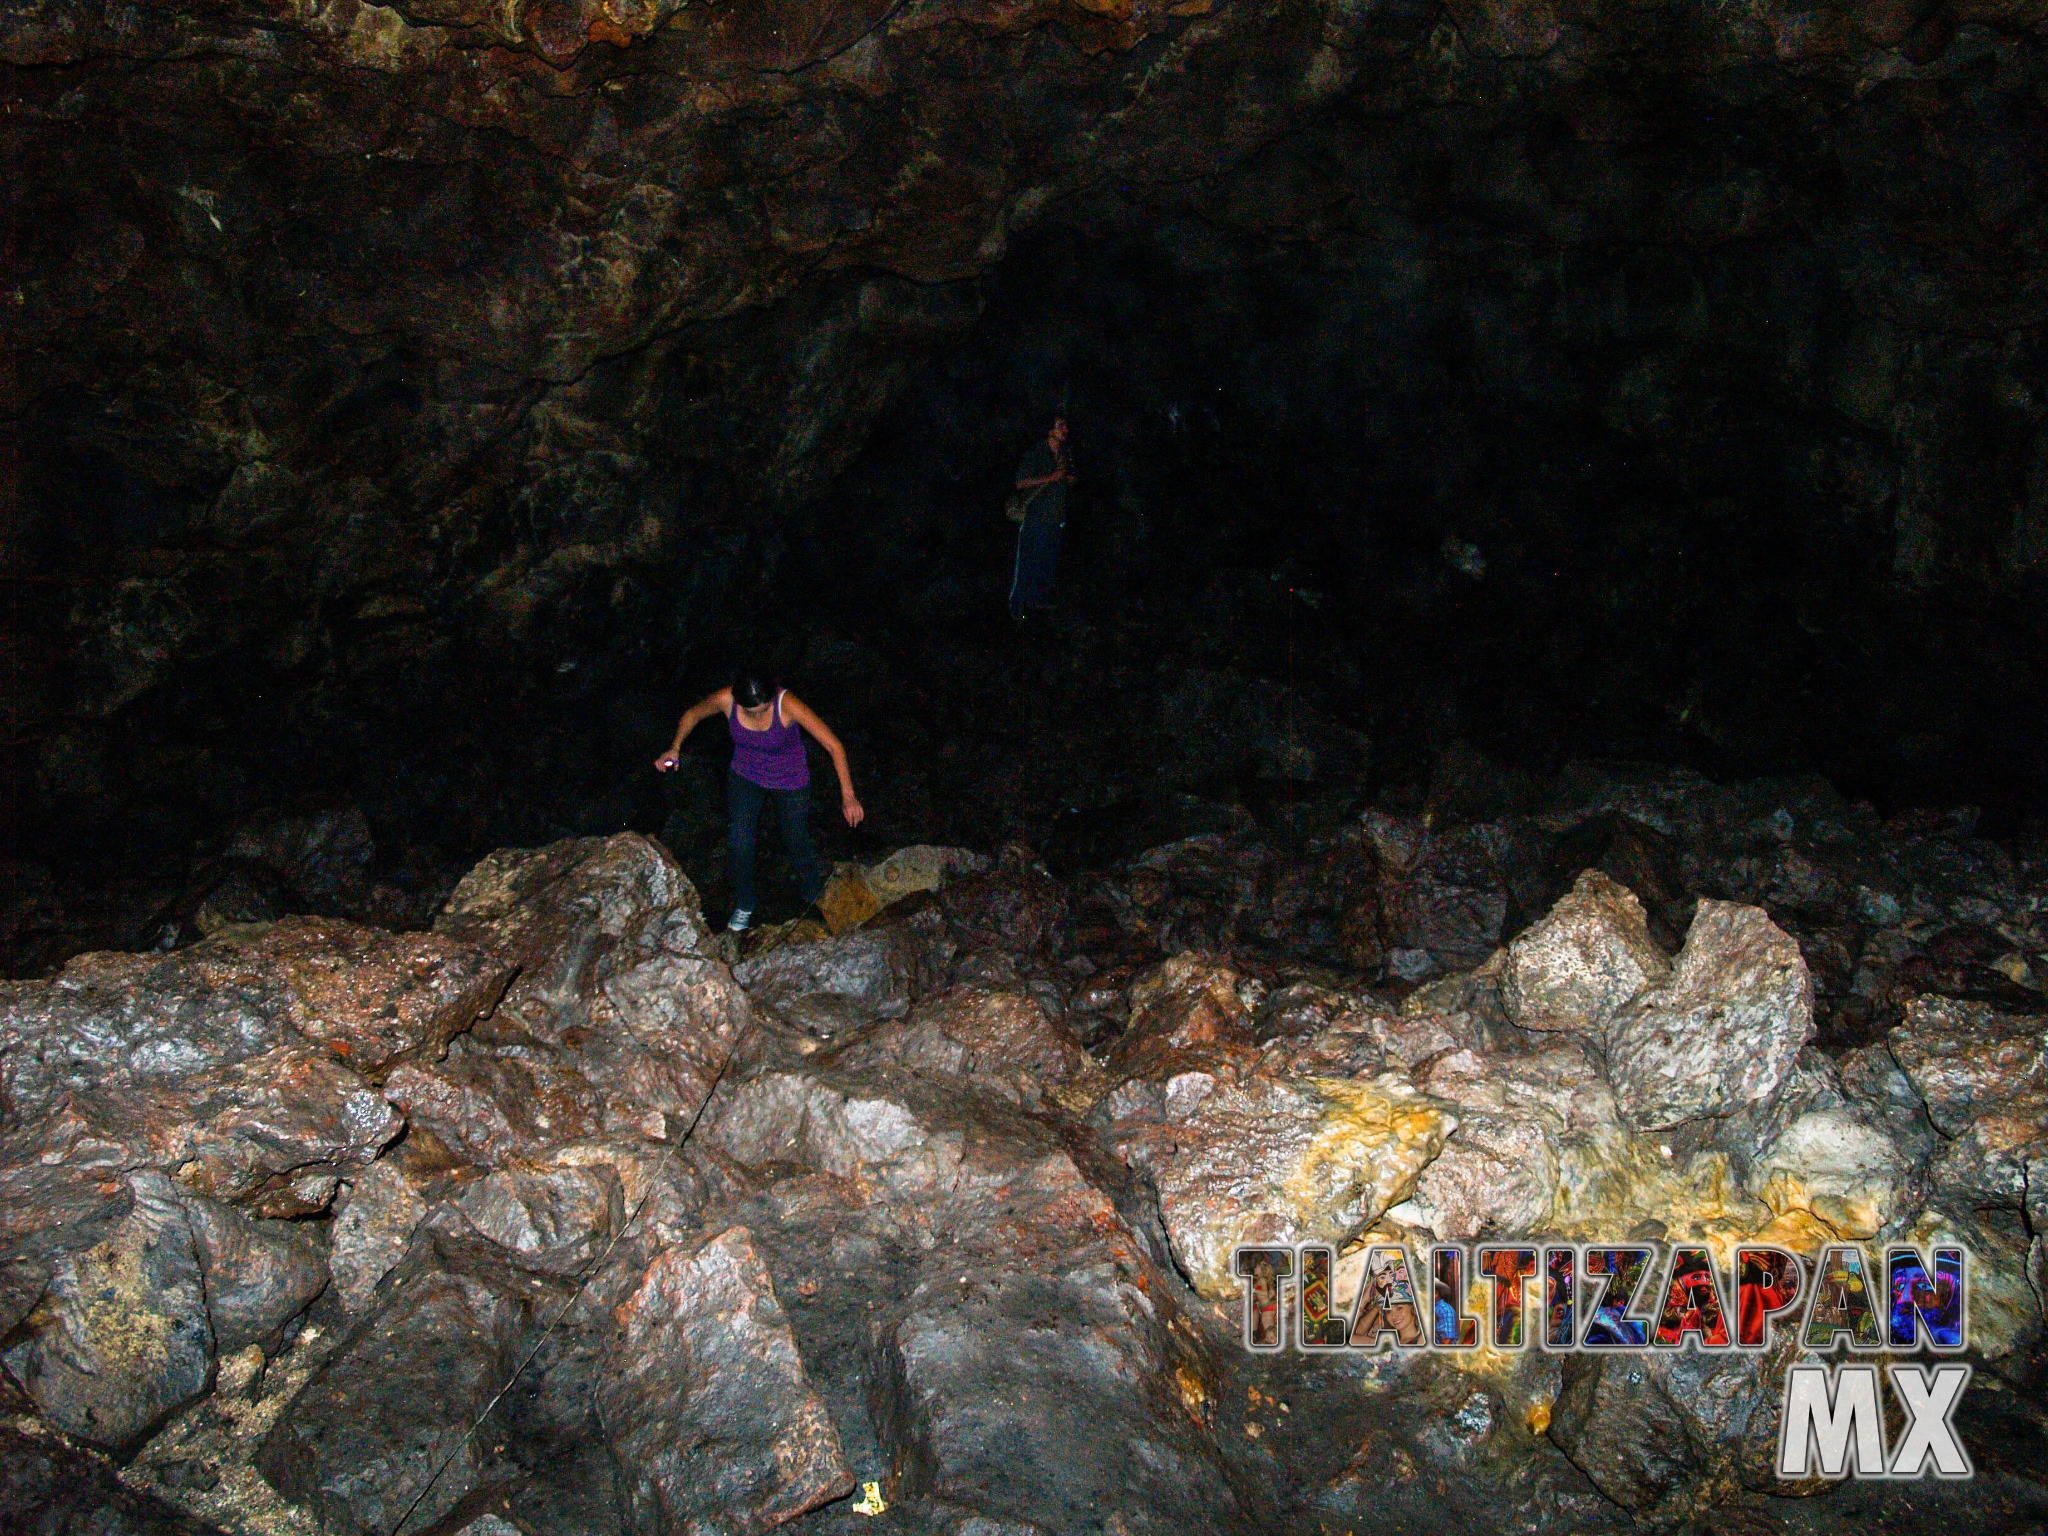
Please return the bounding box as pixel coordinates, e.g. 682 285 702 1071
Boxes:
0 0 2048 966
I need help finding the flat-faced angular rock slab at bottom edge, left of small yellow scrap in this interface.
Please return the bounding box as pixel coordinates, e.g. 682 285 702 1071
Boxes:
598 1227 854 1536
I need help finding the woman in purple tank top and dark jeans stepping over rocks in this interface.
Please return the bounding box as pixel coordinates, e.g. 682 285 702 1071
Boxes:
653 676 866 934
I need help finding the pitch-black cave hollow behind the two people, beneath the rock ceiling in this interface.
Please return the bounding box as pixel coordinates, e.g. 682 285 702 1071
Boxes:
12 204 2048 963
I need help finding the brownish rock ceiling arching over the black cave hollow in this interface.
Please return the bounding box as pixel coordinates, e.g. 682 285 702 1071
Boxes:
0 0 2048 876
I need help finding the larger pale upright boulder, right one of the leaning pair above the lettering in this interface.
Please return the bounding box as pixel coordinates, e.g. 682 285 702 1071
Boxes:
1606 901 1812 1130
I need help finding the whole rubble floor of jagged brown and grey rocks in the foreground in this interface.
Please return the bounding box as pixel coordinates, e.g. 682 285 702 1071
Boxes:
0 768 2048 1536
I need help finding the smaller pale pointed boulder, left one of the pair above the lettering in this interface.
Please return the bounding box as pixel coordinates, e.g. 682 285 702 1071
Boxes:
1501 870 1671 1036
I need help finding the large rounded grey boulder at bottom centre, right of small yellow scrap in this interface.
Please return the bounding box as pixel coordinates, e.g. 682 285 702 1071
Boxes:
707 1059 1243 1534
